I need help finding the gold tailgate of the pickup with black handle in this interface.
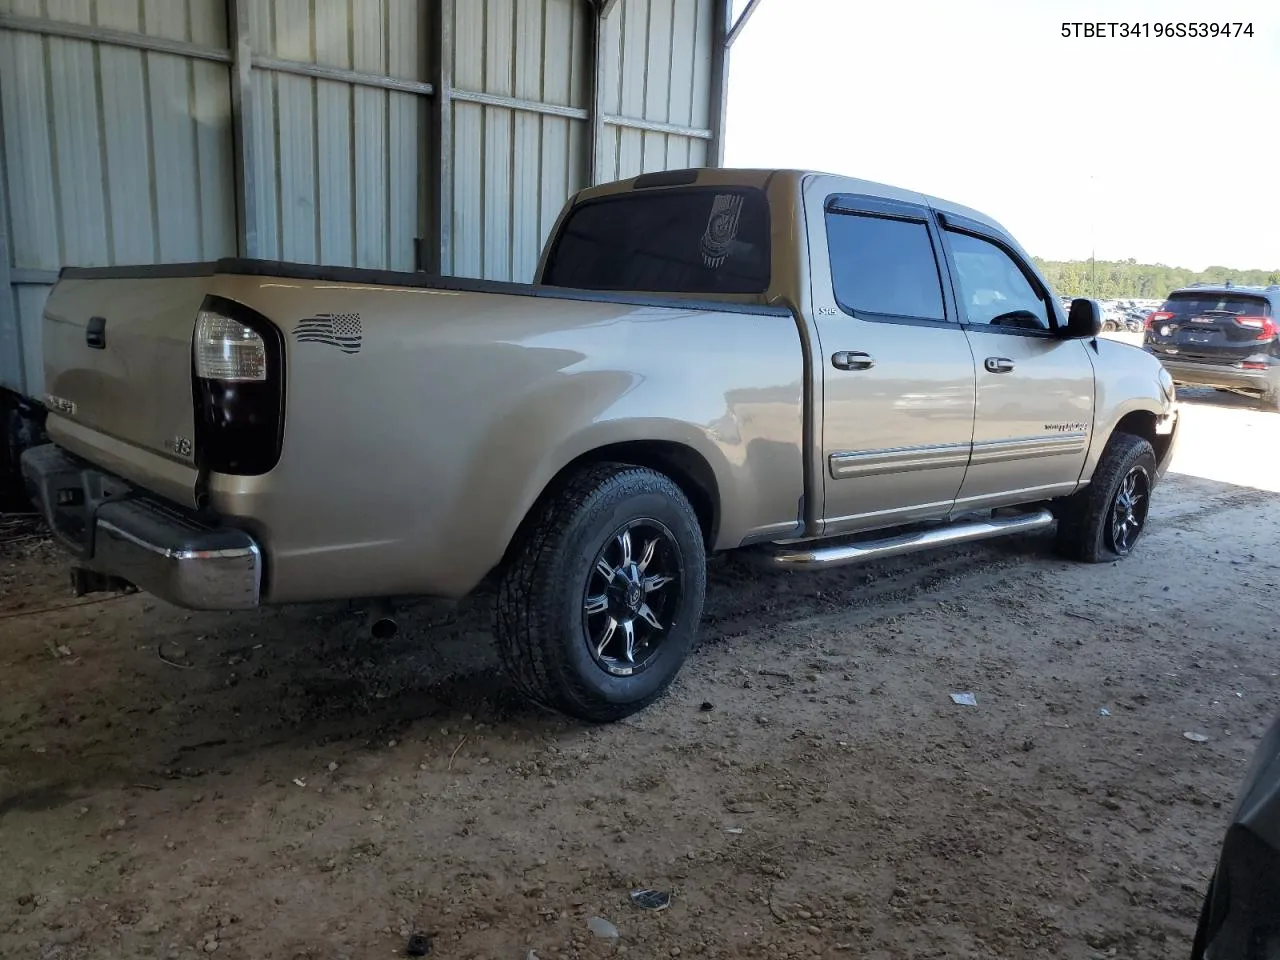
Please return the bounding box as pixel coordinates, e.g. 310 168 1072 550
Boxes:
44 271 211 506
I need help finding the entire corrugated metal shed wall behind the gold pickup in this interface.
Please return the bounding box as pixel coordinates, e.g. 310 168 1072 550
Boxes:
0 0 727 397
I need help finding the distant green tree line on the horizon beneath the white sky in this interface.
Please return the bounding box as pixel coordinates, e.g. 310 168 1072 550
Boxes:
1033 257 1280 300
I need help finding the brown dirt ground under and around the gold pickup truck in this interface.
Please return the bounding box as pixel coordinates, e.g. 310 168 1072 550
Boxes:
0 384 1280 960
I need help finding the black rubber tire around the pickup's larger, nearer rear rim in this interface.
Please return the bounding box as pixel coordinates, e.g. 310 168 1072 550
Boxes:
494 463 707 723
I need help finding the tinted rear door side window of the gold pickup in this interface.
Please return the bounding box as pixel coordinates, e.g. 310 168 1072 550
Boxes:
827 210 946 320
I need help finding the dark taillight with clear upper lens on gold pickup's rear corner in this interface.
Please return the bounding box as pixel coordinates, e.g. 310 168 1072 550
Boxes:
192 297 284 476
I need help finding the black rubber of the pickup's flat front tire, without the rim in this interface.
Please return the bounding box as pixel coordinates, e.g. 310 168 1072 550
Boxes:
1056 433 1156 563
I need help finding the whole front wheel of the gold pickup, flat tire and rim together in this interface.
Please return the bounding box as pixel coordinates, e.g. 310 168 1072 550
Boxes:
1057 433 1156 563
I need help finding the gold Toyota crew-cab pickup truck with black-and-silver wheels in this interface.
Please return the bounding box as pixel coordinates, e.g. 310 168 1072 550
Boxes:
23 169 1176 721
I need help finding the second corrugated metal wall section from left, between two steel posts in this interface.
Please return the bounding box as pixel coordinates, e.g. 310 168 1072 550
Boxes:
251 0 431 270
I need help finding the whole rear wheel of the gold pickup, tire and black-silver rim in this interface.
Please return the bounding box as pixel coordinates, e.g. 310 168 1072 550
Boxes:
494 463 707 722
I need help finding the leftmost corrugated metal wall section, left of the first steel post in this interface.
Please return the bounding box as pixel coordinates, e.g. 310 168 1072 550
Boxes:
0 0 236 396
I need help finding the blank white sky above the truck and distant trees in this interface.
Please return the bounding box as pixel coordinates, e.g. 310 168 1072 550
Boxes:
726 0 1280 270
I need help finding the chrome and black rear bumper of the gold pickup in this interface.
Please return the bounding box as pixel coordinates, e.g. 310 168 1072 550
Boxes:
22 444 262 611
